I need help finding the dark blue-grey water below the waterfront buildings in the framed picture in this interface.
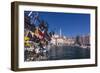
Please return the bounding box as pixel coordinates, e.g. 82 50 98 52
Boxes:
48 46 90 60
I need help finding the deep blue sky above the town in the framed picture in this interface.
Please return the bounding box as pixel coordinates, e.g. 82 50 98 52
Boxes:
24 11 90 37
